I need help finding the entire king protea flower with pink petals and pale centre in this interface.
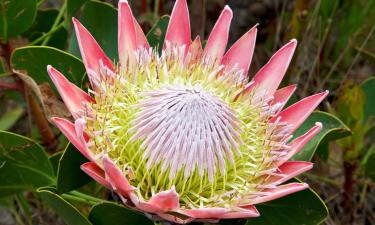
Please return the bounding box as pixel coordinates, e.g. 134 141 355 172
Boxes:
48 0 328 223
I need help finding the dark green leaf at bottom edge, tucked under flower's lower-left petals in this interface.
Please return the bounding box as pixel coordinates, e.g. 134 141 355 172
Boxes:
89 203 154 225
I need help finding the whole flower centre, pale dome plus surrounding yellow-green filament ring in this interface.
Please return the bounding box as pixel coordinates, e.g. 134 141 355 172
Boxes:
86 47 286 208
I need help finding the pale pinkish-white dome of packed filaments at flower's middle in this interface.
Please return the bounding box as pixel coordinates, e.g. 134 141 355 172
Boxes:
130 85 242 180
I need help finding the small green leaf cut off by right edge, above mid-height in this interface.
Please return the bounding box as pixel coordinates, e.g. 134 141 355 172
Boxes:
361 77 375 121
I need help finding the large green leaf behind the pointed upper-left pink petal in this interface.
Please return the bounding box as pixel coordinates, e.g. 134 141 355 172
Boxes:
68 1 118 61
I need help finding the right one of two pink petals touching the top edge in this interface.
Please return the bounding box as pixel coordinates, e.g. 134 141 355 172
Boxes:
164 0 191 50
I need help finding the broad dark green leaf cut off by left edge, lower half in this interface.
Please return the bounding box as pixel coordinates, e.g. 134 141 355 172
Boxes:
0 131 55 197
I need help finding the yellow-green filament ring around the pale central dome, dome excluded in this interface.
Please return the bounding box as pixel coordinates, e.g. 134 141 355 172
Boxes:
83 47 280 208
